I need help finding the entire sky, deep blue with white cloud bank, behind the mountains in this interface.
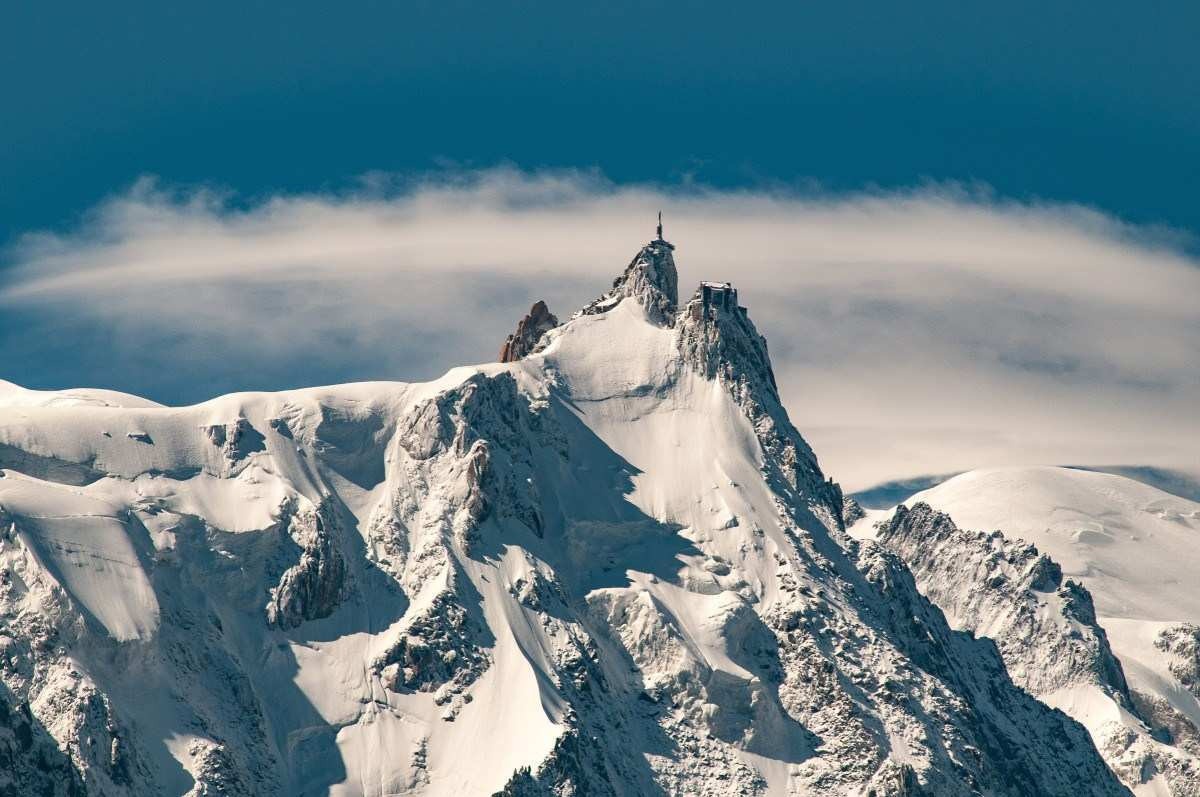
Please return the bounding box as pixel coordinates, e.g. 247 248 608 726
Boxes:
0 1 1200 487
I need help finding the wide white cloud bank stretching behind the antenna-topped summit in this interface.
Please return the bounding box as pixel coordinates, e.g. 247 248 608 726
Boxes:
0 170 1200 490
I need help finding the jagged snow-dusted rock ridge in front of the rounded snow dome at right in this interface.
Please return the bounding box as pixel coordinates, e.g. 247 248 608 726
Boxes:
876 503 1200 796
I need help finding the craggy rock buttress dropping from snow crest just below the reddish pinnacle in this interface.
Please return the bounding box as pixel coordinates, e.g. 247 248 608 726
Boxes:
372 374 562 720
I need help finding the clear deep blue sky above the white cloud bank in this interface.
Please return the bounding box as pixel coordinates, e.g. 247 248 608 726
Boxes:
7 0 1200 241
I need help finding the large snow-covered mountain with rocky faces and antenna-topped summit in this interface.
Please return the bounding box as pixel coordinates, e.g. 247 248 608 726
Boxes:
0 241 1127 797
